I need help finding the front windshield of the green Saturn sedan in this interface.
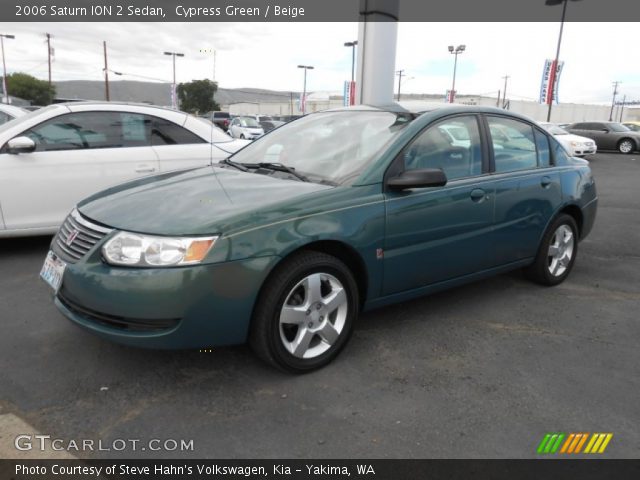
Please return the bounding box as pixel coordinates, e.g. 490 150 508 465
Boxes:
232 110 414 185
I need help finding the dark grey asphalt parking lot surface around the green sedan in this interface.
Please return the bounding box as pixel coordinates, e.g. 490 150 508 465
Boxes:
0 153 640 458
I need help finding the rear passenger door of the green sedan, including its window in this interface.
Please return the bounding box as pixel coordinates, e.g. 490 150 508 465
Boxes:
485 115 562 266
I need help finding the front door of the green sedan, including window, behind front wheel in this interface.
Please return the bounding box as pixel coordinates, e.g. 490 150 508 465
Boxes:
383 115 495 295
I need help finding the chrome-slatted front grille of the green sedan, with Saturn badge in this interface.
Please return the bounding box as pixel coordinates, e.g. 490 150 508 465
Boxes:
53 209 111 263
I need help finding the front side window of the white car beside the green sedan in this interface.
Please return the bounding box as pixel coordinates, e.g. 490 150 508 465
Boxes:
24 111 148 152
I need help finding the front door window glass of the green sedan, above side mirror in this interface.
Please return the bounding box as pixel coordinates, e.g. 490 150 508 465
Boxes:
404 116 482 180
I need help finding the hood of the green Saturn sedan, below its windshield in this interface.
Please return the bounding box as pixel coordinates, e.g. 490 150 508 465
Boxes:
78 167 334 235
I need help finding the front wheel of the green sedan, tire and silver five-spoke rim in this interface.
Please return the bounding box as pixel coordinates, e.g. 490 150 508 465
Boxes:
249 251 359 373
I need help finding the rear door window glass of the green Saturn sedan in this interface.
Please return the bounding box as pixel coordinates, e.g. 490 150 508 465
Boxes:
487 117 538 173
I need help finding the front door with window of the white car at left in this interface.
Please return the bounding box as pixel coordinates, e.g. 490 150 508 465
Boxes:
0 111 159 230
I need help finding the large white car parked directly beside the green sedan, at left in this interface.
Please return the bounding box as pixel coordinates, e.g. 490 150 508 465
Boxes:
0 102 249 237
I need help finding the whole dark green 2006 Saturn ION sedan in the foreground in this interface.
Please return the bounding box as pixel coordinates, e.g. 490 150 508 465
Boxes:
41 106 597 372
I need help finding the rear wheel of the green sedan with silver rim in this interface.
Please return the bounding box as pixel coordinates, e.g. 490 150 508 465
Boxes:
525 214 578 286
